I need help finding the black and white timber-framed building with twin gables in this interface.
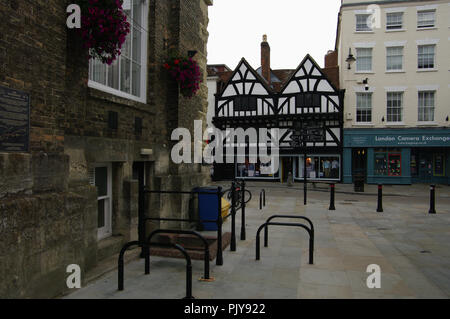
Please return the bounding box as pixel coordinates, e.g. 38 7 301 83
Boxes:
213 38 344 182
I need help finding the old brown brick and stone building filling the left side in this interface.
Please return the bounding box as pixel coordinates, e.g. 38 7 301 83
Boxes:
0 0 212 298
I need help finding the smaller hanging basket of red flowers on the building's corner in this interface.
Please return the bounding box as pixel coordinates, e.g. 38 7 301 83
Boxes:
164 57 203 98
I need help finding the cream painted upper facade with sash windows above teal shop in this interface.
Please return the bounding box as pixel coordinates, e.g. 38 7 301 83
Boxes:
336 0 450 128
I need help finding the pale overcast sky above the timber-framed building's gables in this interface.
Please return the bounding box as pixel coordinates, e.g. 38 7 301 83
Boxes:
208 0 341 69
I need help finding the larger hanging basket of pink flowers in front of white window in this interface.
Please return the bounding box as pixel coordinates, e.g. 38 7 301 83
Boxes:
78 0 130 65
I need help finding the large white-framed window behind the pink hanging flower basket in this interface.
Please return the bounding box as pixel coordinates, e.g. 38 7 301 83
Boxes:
88 0 148 103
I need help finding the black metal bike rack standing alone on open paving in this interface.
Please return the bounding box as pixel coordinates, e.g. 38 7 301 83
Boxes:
256 215 314 265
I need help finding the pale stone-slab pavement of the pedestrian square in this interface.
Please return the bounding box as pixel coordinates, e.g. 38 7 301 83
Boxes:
64 182 450 299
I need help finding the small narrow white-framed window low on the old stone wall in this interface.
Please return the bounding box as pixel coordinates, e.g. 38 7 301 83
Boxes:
89 163 112 240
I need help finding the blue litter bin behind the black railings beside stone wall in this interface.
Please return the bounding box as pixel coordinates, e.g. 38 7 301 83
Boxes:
194 187 219 230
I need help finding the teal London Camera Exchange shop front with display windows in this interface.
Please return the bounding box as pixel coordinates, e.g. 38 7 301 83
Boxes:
343 128 450 184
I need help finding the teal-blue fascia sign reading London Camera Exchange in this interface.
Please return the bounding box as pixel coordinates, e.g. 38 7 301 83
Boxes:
344 129 450 147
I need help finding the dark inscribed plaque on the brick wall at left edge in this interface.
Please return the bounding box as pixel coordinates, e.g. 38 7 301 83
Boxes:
0 86 30 152
